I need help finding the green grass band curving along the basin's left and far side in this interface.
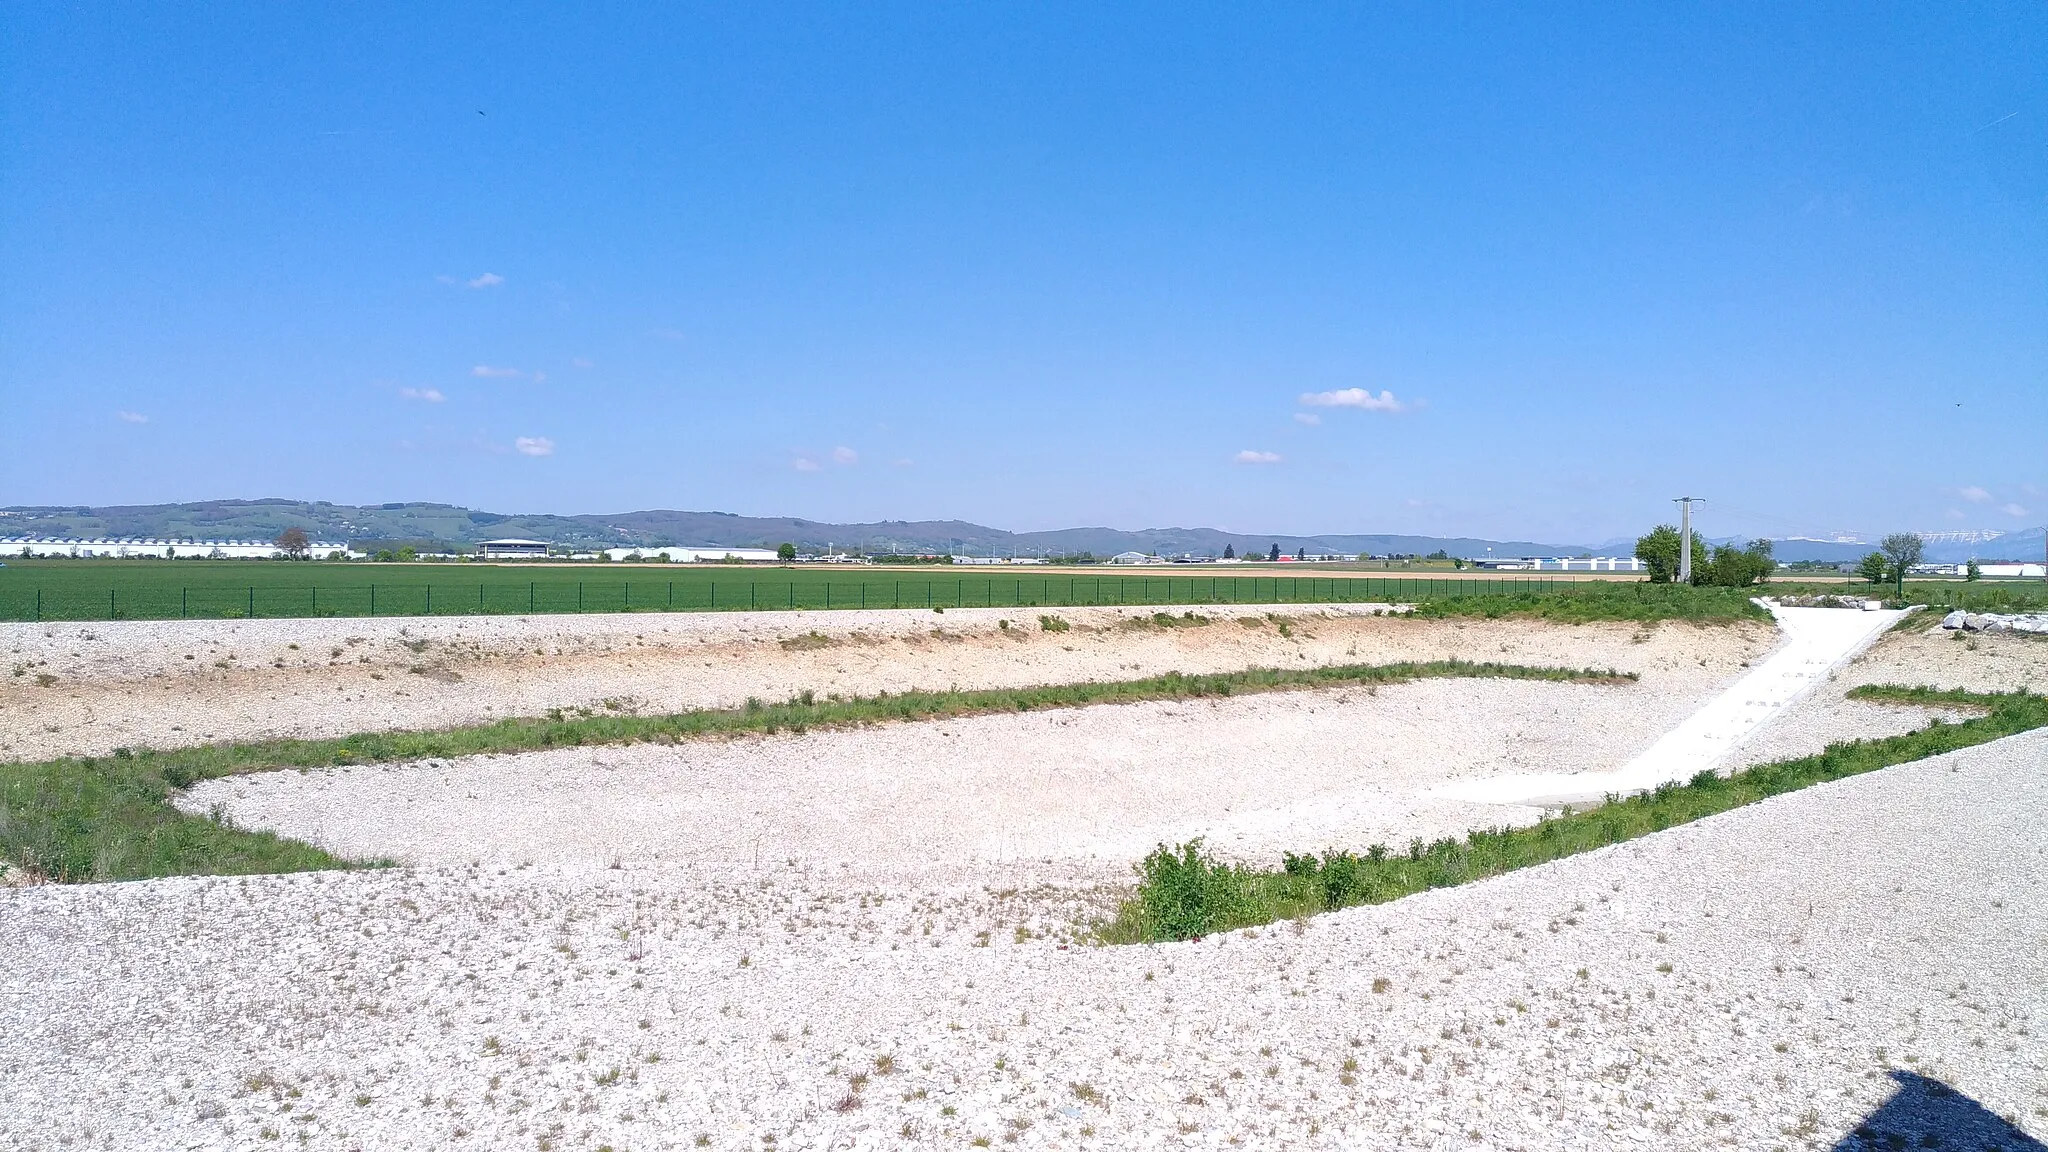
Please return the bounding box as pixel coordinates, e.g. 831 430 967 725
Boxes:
0 660 1632 881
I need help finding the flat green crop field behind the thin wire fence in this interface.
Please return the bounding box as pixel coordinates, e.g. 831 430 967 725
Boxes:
0 560 1613 621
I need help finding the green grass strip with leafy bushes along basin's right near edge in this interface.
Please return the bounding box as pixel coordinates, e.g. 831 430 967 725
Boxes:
1102 685 2048 943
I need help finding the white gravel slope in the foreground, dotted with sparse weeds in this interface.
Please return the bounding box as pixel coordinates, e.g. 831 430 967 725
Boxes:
0 732 2048 1150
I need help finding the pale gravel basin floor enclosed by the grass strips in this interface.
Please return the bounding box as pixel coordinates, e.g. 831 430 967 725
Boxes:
180 681 1690 877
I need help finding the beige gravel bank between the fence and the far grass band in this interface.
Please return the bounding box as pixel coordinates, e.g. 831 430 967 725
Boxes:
0 605 1774 760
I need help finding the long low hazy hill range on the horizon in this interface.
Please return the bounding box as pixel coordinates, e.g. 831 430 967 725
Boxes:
0 500 1589 558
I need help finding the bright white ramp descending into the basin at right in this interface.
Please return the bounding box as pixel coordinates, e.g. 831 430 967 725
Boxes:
1434 601 1911 806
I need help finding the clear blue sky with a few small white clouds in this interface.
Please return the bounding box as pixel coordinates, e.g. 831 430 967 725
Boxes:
0 2 2048 541
